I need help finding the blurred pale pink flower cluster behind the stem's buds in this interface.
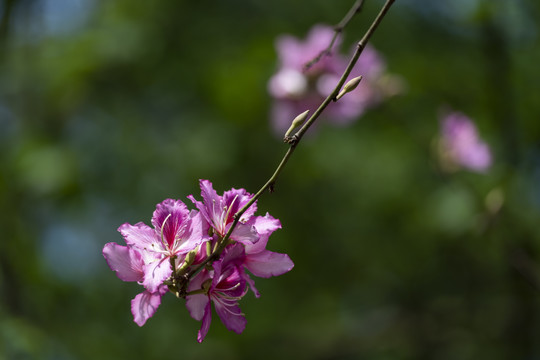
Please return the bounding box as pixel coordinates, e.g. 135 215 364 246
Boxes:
268 25 402 136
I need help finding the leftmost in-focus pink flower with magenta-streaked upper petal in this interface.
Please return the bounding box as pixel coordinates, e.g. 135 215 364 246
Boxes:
103 199 209 326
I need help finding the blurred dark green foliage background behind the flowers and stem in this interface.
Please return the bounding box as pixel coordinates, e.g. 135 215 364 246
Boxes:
0 0 540 360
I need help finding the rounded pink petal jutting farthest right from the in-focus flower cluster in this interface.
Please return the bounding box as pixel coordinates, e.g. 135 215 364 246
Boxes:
245 250 294 278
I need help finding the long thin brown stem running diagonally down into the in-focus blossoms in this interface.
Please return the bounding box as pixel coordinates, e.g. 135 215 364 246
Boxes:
182 0 395 287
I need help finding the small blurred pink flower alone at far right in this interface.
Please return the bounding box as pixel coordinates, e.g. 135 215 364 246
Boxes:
441 112 492 172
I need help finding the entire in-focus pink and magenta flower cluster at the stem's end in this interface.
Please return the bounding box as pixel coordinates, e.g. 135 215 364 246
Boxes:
103 180 294 342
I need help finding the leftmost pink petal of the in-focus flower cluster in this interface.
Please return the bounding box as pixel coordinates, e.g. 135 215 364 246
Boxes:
103 243 144 281
